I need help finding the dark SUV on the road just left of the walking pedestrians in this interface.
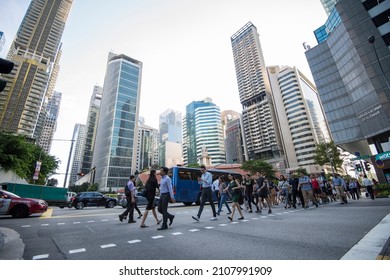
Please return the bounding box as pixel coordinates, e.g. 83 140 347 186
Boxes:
71 192 118 209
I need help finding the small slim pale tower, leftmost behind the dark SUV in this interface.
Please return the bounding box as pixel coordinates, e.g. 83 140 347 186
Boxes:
69 123 87 186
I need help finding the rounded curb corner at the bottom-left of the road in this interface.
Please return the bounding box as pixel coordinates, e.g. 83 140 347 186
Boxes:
0 227 25 260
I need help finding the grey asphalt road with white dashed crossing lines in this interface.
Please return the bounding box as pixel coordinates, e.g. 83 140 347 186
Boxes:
0 199 390 260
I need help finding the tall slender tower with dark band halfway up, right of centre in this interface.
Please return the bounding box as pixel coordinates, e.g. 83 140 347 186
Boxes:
230 22 283 160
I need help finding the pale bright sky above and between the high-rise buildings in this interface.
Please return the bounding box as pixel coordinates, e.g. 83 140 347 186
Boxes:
0 0 327 186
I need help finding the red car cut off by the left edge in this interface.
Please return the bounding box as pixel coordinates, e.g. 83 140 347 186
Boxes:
0 190 47 218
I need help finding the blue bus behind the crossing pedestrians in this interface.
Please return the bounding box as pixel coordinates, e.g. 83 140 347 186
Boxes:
168 166 242 206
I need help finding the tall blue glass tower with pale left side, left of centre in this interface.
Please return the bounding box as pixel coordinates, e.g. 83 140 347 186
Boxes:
92 53 142 191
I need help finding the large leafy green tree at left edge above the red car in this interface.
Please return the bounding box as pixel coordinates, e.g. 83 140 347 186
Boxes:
0 132 60 185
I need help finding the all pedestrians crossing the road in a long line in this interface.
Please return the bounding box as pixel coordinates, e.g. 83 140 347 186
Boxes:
119 166 375 230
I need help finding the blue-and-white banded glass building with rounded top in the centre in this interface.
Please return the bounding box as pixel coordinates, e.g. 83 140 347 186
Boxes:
183 98 226 165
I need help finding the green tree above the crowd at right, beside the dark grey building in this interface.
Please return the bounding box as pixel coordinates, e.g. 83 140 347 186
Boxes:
314 141 343 174
